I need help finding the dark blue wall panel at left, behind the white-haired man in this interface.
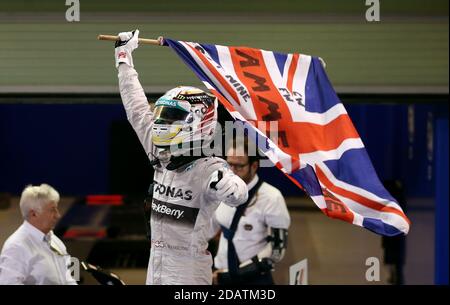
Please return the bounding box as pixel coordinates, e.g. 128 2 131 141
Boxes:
0 104 125 195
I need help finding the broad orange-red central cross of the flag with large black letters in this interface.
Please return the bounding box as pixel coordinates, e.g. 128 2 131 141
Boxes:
230 47 359 157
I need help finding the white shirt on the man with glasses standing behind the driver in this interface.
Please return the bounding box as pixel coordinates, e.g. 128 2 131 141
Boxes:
212 175 291 269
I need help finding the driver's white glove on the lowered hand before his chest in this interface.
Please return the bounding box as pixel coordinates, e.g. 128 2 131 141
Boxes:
208 170 248 205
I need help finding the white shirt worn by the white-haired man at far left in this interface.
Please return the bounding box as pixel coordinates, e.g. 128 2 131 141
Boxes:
0 221 77 285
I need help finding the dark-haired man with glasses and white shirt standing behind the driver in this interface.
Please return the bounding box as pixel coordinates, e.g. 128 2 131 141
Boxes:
211 138 290 285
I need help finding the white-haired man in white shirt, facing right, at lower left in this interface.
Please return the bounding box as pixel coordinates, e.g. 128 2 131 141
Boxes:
0 184 77 285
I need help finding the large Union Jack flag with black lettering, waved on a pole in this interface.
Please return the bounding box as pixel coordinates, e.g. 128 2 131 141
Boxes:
164 39 410 236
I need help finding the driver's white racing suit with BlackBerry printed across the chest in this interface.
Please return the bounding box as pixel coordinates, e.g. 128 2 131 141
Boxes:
119 64 248 285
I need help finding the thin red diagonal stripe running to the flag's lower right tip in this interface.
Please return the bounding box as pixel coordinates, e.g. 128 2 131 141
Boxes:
315 164 410 224
